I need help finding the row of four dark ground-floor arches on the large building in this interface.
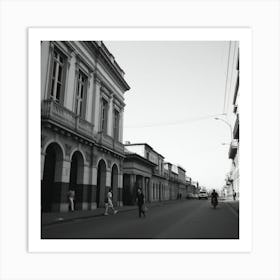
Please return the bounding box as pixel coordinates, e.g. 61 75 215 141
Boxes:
41 142 120 212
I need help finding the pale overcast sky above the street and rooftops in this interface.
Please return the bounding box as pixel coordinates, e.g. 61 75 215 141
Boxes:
105 41 232 188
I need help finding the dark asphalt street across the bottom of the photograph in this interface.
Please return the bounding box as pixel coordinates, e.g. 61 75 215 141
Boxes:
42 200 239 239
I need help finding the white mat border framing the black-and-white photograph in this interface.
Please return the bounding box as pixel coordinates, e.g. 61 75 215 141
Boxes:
28 28 252 253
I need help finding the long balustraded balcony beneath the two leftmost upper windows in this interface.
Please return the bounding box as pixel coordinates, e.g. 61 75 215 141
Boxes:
41 100 94 138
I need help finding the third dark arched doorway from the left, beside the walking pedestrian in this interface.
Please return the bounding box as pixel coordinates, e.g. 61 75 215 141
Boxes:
96 159 106 207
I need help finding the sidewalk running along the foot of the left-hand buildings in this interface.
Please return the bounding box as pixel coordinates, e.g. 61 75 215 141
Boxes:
41 199 186 226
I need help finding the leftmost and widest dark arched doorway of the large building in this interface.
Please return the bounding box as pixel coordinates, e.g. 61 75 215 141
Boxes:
41 143 63 212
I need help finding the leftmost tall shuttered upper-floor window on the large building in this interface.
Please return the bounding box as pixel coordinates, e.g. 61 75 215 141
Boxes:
50 49 66 102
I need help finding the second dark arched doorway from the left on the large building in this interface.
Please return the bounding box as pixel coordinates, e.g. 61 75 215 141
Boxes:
69 151 84 210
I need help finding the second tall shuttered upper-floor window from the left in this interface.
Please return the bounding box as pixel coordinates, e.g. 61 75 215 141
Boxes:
76 70 87 118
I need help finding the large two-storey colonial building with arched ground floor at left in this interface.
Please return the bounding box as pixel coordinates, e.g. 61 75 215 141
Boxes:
41 41 129 212
